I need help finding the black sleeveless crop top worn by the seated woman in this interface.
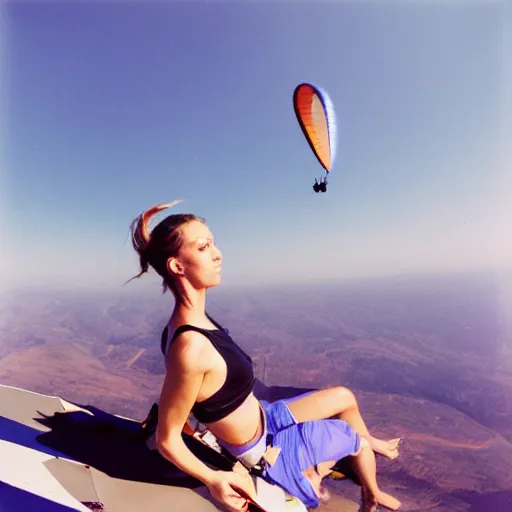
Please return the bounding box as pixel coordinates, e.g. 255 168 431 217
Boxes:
161 317 254 423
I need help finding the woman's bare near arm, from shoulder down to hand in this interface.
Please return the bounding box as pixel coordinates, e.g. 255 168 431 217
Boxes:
156 331 255 510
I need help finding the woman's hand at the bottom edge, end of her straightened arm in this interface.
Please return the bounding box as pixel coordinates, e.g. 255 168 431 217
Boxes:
207 471 256 512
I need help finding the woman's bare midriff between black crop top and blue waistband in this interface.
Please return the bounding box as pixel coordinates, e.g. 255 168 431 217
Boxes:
206 393 263 446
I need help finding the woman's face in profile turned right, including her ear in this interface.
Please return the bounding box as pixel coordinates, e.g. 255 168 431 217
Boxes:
168 220 222 289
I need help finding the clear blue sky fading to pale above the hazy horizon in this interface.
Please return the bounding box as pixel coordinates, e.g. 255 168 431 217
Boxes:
0 0 512 287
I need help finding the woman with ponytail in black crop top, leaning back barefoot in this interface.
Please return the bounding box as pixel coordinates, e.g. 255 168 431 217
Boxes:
127 201 400 511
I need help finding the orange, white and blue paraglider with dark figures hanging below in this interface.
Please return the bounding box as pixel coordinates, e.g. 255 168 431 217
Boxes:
293 83 336 192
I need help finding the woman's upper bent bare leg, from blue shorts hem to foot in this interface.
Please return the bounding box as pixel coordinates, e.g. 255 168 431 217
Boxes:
285 386 401 459
